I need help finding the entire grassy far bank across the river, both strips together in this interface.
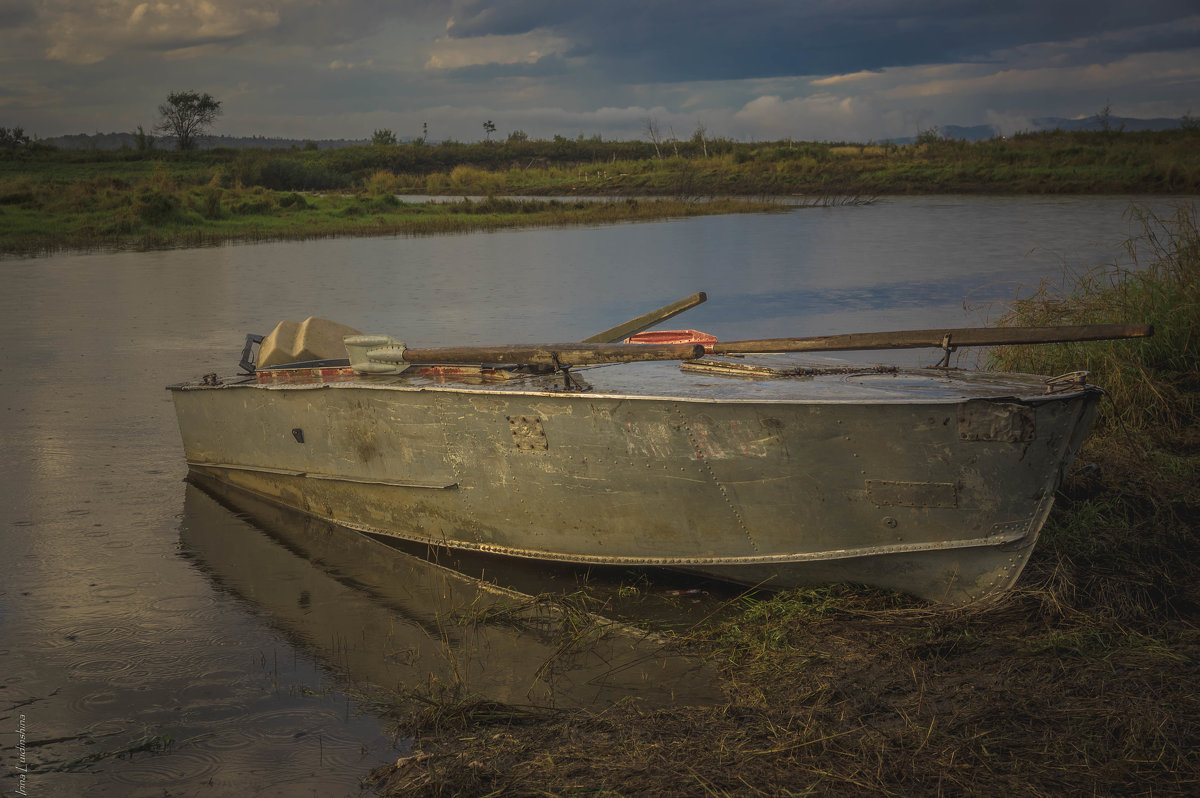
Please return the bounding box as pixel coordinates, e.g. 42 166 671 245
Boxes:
0 128 1200 253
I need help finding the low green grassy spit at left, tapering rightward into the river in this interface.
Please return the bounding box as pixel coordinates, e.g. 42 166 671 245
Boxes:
0 173 779 254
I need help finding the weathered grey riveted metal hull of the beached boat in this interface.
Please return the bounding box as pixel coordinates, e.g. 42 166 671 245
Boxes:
166 355 1099 601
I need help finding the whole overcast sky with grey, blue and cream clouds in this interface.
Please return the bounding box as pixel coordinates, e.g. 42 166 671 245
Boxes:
7 0 1200 142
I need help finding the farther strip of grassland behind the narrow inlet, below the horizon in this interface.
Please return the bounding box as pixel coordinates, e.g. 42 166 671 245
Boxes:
0 128 1200 196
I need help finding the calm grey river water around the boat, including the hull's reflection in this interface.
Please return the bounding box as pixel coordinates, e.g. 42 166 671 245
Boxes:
0 197 1171 796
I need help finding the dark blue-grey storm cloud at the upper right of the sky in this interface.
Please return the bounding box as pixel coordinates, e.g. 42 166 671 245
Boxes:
448 0 1200 82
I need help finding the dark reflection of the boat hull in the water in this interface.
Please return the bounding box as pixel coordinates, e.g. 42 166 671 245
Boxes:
180 476 721 706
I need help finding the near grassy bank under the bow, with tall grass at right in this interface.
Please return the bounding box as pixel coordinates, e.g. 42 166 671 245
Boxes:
371 206 1200 796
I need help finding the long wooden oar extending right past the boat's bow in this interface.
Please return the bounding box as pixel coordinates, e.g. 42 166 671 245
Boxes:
713 324 1154 355
